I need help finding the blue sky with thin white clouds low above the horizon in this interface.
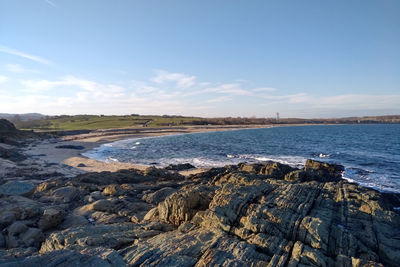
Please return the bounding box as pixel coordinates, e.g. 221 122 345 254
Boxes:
0 0 400 118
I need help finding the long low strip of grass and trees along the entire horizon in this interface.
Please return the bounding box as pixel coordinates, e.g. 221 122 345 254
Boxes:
14 114 400 131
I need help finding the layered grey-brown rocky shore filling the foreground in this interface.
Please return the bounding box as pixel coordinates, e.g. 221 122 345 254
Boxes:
0 120 400 267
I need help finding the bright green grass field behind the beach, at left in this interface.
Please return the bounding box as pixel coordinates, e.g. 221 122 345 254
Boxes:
16 115 201 131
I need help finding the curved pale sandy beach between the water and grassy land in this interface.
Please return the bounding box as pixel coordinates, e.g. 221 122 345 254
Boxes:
24 125 271 175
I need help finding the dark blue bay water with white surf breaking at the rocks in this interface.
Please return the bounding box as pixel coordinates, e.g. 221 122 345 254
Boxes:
84 124 400 193
